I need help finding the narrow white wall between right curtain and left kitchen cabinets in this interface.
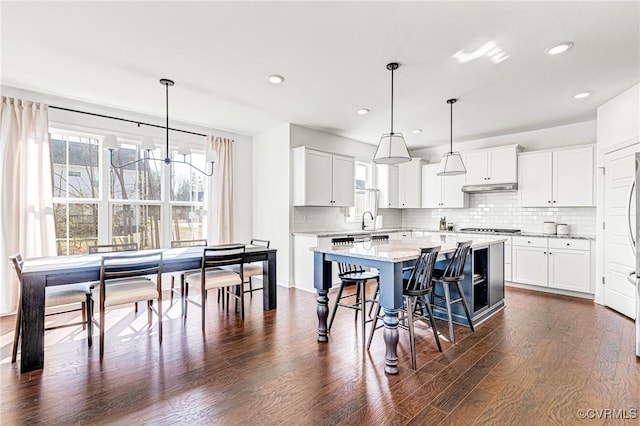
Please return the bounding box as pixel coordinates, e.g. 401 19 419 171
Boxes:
252 124 293 286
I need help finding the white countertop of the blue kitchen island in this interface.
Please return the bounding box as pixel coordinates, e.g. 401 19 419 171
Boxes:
311 235 506 262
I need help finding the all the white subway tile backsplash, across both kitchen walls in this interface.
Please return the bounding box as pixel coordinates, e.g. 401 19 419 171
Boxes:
293 192 596 235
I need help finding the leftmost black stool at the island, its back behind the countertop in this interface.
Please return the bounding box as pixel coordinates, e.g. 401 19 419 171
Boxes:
327 237 380 346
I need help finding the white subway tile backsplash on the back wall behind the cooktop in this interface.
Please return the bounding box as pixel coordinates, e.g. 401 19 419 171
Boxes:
402 191 596 235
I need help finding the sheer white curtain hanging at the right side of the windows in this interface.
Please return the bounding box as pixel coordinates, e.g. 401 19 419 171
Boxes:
204 136 233 244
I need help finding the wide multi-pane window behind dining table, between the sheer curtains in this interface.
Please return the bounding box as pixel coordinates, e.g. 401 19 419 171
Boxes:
51 130 205 255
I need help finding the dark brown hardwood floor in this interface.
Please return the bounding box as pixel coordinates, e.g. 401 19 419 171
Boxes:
0 288 640 425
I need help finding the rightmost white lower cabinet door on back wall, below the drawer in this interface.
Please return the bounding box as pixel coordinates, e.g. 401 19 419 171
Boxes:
549 248 591 293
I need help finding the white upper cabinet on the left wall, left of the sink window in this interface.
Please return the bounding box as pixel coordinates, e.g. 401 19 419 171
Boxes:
292 146 355 207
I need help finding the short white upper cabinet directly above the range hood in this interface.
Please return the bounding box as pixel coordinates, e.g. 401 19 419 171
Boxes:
463 145 519 185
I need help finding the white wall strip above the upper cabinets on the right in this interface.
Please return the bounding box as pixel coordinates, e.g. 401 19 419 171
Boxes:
411 121 596 163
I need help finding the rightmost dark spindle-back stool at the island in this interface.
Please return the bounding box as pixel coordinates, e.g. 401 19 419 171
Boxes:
431 241 475 343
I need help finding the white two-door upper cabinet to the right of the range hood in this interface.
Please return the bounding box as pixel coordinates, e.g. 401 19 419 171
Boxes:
518 146 594 207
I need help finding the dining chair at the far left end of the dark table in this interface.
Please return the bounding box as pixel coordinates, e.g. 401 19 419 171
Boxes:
9 253 93 364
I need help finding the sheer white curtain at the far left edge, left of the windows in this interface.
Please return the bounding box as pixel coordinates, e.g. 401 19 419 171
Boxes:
0 96 56 313
